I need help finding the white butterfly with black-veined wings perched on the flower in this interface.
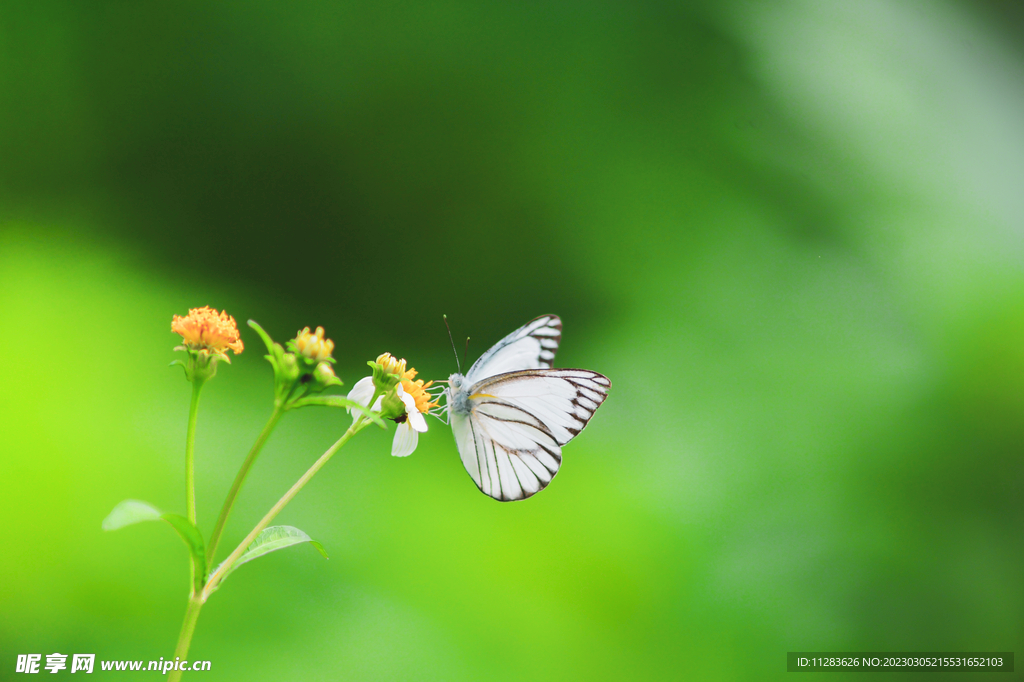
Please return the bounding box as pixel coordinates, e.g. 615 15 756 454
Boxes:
444 315 611 502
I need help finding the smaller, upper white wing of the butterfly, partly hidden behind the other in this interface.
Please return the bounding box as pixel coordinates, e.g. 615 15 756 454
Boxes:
466 315 562 384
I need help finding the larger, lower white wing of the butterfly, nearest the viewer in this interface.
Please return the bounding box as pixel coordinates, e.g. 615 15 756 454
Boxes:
452 370 611 502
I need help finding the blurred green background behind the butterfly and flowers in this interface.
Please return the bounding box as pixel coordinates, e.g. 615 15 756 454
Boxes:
0 0 1024 680
